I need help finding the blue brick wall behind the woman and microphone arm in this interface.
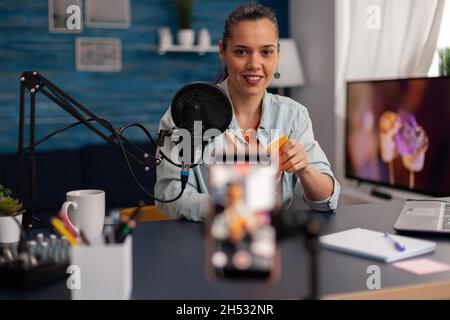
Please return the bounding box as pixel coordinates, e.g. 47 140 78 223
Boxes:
0 0 255 153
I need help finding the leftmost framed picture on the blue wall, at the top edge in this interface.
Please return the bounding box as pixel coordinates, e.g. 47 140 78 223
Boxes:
48 0 83 33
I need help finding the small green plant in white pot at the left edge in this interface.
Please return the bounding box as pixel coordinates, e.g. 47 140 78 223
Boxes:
0 185 25 243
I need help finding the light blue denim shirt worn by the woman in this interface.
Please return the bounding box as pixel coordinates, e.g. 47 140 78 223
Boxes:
155 79 340 221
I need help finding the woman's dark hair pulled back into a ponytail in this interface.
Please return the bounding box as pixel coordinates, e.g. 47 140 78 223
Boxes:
216 3 280 82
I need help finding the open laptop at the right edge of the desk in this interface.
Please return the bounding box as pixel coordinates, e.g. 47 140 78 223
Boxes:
394 200 450 234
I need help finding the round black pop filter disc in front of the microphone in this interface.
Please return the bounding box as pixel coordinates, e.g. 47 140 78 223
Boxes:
171 82 233 132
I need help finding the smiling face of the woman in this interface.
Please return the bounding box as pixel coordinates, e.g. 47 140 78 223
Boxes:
219 18 280 96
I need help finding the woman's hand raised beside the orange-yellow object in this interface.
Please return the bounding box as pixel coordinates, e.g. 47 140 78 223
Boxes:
278 139 309 175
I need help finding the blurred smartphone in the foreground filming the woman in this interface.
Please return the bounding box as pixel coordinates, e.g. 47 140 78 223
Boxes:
205 163 279 279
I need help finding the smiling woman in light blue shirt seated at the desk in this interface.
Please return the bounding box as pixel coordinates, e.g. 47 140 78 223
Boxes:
155 4 340 221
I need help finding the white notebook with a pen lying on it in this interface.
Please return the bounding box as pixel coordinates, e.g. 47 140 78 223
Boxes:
320 228 436 263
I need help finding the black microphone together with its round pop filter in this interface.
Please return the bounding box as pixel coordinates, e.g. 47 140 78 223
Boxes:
171 82 233 164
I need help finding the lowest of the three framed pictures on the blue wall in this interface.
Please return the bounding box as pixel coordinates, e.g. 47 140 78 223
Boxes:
75 37 122 72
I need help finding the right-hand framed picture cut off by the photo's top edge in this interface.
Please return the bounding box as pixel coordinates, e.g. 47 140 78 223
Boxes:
85 0 131 29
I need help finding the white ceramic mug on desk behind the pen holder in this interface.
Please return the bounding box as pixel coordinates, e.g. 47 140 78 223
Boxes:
61 190 105 240
